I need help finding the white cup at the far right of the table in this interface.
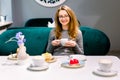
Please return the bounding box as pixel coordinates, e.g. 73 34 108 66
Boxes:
99 59 112 72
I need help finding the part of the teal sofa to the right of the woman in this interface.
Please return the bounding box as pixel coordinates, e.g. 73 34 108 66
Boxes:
80 26 110 55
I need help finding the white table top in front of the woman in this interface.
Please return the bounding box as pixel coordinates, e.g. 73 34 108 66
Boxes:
0 56 120 80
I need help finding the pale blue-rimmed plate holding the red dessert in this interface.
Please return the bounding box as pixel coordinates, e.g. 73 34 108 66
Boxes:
61 61 85 68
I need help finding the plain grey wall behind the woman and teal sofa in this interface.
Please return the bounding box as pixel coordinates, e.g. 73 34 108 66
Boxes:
3 0 120 50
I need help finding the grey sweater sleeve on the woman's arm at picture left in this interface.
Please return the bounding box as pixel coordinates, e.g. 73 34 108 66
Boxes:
46 30 55 54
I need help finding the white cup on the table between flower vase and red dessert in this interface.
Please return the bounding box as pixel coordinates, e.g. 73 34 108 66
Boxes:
32 56 45 67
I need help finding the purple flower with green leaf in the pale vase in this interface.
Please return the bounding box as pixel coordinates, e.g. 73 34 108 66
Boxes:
5 32 26 45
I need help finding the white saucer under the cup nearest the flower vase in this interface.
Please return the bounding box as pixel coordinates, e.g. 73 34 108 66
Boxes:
27 65 49 71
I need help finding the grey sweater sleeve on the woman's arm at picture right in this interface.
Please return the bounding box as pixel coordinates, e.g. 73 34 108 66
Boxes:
73 30 84 54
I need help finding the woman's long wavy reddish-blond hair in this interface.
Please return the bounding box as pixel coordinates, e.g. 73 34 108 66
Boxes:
54 5 80 40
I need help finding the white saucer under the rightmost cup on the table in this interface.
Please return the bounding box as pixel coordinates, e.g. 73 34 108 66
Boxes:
93 69 117 77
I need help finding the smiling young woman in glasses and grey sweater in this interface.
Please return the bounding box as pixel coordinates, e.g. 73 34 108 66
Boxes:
46 5 84 55
